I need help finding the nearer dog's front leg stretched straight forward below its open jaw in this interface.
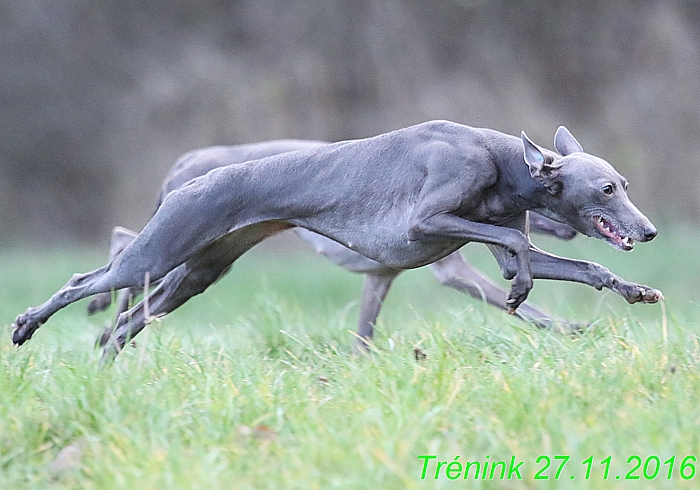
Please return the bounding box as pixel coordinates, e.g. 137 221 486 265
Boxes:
530 247 663 303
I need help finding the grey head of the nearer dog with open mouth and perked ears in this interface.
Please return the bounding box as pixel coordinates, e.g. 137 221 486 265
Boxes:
521 126 657 251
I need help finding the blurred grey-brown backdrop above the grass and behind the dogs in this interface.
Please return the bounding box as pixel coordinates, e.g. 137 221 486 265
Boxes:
0 0 700 246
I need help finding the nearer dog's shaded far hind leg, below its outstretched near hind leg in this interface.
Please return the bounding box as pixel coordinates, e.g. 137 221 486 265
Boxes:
100 222 289 361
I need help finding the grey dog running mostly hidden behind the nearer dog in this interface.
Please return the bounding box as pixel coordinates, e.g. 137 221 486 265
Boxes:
88 140 577 347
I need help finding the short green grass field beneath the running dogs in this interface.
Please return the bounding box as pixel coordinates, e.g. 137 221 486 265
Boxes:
0 226 700 490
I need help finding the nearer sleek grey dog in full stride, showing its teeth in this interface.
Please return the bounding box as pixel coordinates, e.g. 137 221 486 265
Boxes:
12 121 662 357
